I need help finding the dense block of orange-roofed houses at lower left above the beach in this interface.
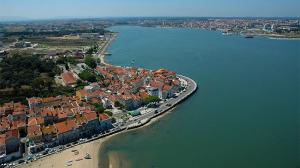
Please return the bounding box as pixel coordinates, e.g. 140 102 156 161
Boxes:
0 96 112 163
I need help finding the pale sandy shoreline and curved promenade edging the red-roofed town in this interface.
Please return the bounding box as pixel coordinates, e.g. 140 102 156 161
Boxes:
17 28 198 168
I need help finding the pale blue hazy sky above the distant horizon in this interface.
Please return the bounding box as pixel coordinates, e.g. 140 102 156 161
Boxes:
0 0 300 19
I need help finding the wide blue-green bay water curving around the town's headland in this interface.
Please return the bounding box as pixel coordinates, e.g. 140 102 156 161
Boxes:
100 26 300 168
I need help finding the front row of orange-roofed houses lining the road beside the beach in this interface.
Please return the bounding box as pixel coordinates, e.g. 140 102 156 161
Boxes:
27 110 112 153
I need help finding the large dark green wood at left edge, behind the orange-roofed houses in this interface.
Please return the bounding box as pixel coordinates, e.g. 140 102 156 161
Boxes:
0 55 75 104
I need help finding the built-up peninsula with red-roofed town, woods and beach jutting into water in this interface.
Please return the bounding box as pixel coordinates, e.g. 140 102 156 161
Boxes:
0 20 197 167
